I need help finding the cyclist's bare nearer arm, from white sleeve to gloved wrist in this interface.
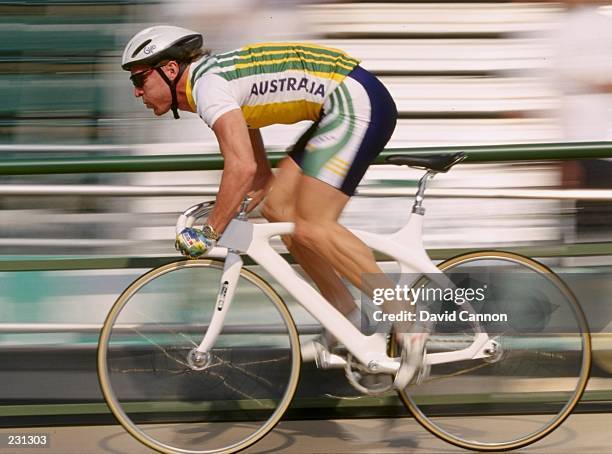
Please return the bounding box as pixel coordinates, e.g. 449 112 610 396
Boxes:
208 109 257 233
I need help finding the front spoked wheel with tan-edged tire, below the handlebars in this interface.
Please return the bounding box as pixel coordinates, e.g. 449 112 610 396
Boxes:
98 260 300 453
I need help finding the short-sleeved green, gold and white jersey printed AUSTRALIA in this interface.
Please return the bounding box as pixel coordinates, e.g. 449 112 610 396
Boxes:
186 43 359 128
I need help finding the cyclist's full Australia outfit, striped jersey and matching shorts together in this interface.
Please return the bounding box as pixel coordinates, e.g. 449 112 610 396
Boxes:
186 43 397 196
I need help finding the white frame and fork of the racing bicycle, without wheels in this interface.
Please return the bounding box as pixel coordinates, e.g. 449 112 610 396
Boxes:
177 176 494 373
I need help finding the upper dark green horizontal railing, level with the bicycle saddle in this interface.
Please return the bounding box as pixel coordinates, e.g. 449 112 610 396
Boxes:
0 142 612 175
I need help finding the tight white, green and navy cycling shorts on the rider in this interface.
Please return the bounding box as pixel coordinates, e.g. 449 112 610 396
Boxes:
289 66 397 196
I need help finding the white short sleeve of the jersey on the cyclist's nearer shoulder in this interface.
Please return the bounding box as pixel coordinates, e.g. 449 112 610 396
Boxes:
194 73 240 128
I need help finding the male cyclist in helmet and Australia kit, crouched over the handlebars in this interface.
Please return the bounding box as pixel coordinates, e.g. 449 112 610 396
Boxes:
122 26 420 378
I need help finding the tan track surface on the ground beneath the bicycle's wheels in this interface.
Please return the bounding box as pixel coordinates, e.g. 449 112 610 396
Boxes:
0 413 612 454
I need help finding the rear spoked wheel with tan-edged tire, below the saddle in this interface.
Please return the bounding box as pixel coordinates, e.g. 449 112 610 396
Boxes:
399 251 591 451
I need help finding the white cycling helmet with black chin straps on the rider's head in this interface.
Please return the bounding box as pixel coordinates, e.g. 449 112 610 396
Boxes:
121 25 203 118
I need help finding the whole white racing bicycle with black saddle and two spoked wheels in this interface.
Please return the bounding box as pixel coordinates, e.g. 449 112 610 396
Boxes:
97 153 591 453
